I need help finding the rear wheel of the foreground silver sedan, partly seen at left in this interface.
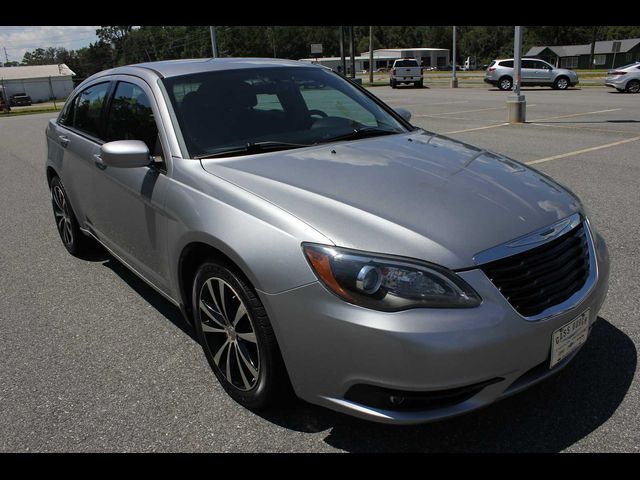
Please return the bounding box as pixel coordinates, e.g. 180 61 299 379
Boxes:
50 176 96 257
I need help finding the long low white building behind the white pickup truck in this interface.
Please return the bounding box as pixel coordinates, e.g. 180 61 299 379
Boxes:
300 48 449 73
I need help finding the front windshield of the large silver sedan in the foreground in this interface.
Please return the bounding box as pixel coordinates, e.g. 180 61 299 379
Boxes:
163 67 407 158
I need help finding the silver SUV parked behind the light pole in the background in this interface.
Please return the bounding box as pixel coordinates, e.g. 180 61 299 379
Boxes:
484 58 579 90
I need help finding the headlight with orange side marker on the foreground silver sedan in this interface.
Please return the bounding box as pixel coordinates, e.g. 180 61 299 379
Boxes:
302 243 482 312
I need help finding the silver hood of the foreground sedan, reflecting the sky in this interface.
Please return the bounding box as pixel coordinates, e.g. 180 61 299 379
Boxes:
201 130 581 269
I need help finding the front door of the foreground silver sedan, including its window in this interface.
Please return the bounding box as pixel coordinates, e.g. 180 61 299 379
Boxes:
92 77 169 291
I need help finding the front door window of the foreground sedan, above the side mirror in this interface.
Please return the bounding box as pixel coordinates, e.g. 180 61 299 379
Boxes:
106 82 162 160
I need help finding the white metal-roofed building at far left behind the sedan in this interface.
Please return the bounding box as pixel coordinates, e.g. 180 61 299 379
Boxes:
0 63 75 103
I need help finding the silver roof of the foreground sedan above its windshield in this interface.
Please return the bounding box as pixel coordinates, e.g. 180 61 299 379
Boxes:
105 58 317 78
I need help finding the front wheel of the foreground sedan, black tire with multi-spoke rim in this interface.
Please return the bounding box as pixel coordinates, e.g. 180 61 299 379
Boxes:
192 260 293 410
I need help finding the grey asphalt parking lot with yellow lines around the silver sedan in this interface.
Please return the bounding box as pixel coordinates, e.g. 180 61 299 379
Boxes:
0 83 640 452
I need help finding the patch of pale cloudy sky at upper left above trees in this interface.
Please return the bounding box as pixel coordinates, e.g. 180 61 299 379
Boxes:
0 26 100 62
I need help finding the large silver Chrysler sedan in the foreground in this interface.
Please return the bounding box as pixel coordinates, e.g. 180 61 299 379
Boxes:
46 58 609 424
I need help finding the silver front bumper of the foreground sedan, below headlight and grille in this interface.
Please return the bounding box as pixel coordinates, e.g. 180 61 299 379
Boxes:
259 232 609 424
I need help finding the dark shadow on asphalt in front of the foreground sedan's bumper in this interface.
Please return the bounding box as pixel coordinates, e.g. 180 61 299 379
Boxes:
259 318 637 453
